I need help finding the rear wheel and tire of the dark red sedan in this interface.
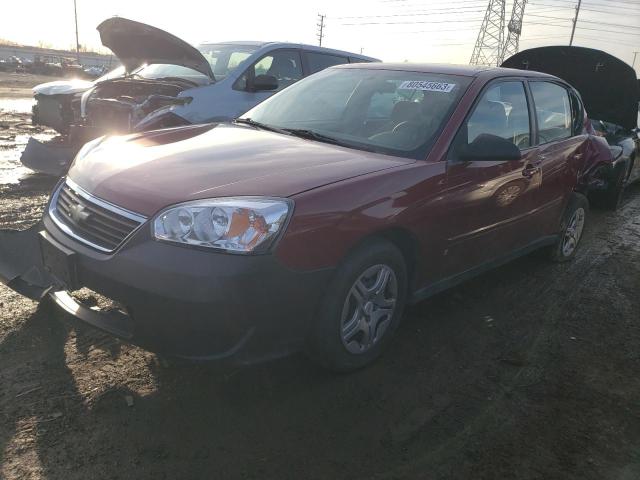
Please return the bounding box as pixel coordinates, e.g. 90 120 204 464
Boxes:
549 192 589 263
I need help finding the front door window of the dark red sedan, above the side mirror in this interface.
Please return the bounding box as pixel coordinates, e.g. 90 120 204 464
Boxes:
458 82 531 148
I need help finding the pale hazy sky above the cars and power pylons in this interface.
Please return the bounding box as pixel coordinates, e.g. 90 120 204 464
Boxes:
0 0 640 71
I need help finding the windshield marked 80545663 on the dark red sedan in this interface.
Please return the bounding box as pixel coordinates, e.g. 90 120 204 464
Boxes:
243 68 471 159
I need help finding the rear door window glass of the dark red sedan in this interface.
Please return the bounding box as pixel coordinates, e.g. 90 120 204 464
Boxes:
529 82 573 144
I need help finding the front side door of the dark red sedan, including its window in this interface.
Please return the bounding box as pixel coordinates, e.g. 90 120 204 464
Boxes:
445 80 540 275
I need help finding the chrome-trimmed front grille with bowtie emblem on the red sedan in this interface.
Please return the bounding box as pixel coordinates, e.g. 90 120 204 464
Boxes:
52 180 146 252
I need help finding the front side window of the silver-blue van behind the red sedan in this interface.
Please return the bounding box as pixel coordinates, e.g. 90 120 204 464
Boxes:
233 50 302 91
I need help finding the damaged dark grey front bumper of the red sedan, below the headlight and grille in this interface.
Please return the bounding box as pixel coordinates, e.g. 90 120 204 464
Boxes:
0 216 332 363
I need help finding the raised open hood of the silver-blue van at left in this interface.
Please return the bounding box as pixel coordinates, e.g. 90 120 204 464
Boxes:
97 17 215 80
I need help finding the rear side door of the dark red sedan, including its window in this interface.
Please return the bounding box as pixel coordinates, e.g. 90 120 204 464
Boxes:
528 80 586 235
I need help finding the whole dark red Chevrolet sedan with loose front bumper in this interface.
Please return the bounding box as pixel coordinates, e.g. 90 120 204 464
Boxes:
0 64 608 371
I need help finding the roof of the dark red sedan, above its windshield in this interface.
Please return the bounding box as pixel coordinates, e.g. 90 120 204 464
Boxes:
332 63 555 78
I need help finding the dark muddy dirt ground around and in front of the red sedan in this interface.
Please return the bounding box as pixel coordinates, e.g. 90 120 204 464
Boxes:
0 79 640 480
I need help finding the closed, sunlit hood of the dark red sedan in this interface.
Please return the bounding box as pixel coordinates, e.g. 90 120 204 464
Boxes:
68 124 415 216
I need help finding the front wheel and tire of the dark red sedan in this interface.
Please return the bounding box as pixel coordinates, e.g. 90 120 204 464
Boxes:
308 240 407 372
